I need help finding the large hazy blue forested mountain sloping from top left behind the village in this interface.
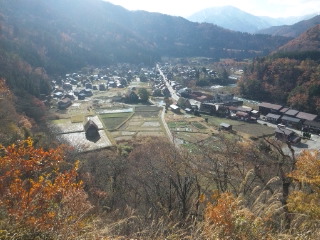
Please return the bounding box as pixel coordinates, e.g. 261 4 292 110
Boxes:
0 0 291 80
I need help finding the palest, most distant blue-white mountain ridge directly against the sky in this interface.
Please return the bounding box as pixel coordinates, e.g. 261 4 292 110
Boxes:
188 6 315 33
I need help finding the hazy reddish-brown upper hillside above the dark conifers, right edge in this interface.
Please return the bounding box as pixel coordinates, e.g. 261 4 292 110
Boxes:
279 24 320 52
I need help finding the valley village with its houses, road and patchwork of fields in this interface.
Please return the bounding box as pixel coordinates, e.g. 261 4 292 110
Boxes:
50 63 320 153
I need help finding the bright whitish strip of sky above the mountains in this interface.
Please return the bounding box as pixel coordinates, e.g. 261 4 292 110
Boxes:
106 0 320 17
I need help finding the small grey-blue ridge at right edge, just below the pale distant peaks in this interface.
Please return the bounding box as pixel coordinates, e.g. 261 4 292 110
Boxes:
257 15 320 38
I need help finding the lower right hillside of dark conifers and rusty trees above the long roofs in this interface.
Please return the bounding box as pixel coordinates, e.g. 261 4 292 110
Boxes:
238 58 320 114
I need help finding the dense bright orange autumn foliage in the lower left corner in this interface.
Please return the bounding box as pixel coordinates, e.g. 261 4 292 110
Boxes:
0 139 91 237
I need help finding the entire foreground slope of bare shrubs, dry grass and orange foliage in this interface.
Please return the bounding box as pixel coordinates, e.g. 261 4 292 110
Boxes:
0 136 320 239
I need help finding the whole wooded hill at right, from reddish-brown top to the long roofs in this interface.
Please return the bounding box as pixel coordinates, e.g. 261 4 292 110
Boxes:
238 25 320 114
